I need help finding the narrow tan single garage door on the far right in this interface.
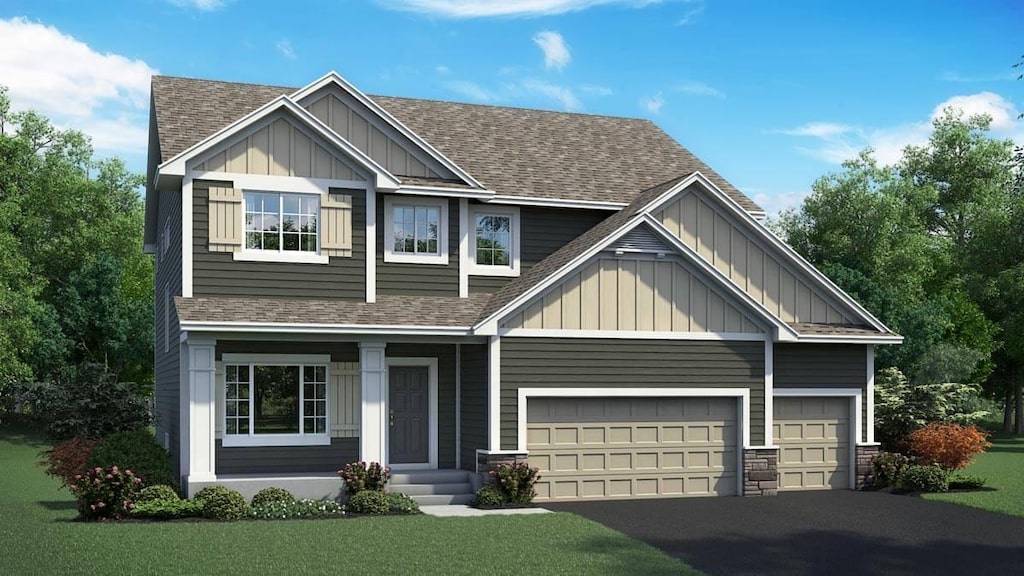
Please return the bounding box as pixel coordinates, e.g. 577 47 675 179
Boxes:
774 397 852 490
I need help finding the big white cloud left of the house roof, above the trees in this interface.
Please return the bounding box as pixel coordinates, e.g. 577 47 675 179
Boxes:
0 17 157 154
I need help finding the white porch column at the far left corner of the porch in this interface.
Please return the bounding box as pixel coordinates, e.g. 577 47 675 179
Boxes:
181 337 217 484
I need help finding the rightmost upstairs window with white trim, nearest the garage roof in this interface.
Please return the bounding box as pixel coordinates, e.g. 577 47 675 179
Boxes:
469 206 519 276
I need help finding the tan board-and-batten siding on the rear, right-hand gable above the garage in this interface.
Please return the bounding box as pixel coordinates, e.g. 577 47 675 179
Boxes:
654 186 860 324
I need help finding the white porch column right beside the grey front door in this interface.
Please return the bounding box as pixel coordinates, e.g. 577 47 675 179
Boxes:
359 342 387 463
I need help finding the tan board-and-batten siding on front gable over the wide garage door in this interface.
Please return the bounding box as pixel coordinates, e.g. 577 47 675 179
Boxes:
503 254 763 333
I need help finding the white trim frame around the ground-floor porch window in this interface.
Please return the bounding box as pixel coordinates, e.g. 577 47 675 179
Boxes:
217 354 332 448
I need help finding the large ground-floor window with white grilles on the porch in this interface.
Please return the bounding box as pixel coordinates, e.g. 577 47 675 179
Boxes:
223 355 331 446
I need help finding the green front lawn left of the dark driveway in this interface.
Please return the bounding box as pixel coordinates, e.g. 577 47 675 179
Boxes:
0 422 697 575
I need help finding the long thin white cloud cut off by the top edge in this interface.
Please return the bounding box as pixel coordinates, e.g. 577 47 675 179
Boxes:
378 0 666 18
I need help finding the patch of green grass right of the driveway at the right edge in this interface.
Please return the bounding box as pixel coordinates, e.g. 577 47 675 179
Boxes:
924 434 1024 518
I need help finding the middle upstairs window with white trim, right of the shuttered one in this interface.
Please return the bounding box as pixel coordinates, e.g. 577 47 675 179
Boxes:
384 197 447 264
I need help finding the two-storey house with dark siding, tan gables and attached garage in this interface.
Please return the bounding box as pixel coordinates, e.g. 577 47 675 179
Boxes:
145 73 901 501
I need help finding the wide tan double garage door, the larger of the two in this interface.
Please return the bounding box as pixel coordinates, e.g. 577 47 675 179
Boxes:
526 398 737 500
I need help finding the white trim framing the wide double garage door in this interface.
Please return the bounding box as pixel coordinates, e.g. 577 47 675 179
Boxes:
516 387 751 494
